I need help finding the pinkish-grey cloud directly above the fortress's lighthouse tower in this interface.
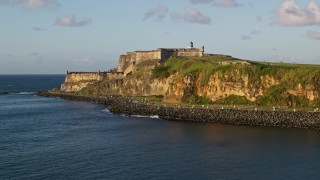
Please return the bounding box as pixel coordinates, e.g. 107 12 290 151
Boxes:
170 8 211 24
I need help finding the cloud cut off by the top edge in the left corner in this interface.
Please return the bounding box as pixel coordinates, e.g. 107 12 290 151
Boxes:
0 0 60 9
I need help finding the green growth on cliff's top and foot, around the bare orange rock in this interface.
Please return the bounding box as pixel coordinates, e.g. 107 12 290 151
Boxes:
153 56 320 107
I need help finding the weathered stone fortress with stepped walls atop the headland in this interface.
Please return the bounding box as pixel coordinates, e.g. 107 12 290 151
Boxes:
61 42 208 91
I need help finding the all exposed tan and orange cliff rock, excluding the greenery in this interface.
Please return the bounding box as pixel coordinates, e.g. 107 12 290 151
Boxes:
71 69 319 106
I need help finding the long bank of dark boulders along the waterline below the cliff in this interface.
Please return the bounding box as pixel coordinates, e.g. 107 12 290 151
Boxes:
39 93 320 130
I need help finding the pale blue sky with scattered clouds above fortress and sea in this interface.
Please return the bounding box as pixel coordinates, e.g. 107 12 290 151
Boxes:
0 0 320 74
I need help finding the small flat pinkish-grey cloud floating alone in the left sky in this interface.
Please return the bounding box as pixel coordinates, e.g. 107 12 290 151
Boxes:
55 15 91 27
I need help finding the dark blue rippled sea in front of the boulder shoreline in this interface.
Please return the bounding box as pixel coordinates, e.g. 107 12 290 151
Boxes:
0 75 320 179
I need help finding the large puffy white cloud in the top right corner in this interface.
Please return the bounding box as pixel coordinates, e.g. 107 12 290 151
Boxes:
274 0 320 26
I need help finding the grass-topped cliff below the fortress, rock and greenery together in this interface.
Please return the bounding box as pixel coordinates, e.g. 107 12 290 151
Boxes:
61 56 320 107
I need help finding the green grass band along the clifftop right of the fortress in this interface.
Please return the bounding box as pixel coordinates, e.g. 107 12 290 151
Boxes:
157 56 320 89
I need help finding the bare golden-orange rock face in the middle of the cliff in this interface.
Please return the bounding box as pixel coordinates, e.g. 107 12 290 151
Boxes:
167 72 279 102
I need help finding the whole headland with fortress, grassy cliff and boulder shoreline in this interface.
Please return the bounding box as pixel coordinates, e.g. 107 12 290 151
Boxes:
41 42 320 129
